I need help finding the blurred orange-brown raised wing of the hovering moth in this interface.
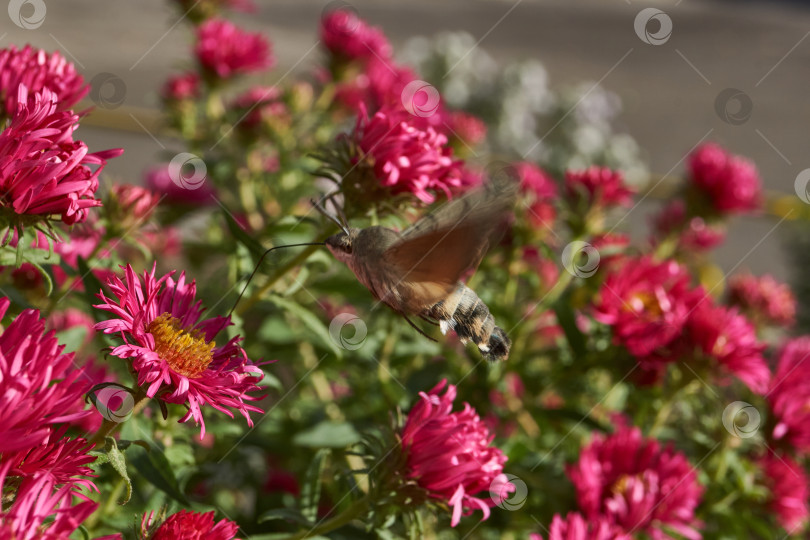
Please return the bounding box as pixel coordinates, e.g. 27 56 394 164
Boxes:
383 175 517 305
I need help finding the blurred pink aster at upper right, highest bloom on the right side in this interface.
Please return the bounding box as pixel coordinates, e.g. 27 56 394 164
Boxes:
688 143 762 214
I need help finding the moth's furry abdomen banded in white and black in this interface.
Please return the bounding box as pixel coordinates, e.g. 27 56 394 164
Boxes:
422 283 511 362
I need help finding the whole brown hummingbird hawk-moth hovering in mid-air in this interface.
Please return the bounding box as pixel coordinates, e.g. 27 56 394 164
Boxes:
326 179 517 361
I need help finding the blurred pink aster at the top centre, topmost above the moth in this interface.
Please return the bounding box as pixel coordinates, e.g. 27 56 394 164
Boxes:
320 9 391 60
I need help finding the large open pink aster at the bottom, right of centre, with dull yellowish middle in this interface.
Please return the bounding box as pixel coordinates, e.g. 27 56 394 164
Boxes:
568 425 703 540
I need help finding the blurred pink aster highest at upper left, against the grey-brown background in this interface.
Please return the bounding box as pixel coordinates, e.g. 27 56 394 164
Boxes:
194 19 275 79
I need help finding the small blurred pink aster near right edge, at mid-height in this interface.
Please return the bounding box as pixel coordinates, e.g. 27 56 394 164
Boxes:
728 274 796 326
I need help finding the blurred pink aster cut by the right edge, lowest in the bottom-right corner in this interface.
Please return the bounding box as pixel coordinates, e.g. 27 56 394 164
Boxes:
759 452 810 534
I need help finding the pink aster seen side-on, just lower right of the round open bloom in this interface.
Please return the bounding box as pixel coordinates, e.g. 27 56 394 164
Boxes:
687 299 771 394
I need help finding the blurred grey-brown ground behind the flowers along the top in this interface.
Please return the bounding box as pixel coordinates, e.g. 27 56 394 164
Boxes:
12 0 810 279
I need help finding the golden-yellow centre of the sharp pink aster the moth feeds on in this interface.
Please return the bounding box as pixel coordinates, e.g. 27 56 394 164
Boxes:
146 313 216 379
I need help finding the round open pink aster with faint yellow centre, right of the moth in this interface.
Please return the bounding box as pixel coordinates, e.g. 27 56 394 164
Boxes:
595 257 703 358
